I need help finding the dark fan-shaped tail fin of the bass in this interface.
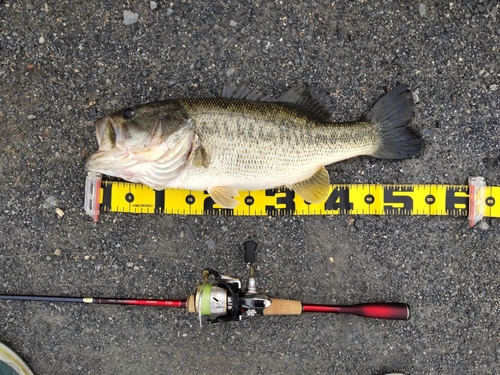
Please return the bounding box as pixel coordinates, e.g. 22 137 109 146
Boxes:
367 85 424 159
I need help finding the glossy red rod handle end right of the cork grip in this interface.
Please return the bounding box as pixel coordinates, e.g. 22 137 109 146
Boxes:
302 302 410 320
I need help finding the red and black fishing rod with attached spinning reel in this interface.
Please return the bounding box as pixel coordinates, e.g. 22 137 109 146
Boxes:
0 241 410 326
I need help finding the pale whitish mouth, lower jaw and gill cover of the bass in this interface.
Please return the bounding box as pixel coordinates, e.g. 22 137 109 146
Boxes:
85 116 196 190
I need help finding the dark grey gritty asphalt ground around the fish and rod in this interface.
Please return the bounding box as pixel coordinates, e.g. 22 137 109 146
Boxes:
0 0 500 375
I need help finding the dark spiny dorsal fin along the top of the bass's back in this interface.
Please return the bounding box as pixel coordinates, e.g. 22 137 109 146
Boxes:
222 83 331 122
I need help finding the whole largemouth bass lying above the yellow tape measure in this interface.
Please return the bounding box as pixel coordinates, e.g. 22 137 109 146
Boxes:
86 85 423 208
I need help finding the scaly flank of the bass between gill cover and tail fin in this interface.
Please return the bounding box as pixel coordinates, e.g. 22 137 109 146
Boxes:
177 98 377 185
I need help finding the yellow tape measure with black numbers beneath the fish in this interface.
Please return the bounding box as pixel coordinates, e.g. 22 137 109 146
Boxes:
85 176 500 225
